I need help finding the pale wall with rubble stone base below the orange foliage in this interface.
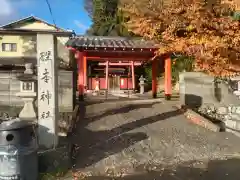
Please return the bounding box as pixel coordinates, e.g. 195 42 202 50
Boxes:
179 72 240 131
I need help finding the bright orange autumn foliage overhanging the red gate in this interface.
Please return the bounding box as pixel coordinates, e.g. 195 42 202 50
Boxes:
121 0 240 76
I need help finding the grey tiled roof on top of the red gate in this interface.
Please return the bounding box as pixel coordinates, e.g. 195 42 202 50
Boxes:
66 36 157 51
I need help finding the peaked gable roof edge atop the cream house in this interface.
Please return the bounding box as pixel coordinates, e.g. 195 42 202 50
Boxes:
0 16 68 31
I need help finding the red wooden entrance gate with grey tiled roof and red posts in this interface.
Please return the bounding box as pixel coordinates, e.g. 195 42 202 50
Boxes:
66 36 172 100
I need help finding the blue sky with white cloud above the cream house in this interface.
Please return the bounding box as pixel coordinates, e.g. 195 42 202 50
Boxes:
0 0 91 34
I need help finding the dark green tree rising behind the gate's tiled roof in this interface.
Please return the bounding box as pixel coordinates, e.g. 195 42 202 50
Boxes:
85 0 134 37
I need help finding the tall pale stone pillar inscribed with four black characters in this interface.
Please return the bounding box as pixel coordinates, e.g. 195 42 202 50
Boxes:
37 34 58 148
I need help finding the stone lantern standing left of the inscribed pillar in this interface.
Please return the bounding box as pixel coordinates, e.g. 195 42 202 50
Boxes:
16 63 37 120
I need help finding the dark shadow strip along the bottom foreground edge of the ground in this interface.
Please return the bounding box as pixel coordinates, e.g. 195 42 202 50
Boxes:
72 159 240 180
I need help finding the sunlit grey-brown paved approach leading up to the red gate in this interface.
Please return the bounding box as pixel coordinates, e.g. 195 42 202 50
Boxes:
70 101 240 180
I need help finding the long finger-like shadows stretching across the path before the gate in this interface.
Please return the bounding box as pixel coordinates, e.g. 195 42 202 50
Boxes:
72 103 183 169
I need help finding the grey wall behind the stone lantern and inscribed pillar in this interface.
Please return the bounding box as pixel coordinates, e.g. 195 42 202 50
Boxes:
0 70 73 111
